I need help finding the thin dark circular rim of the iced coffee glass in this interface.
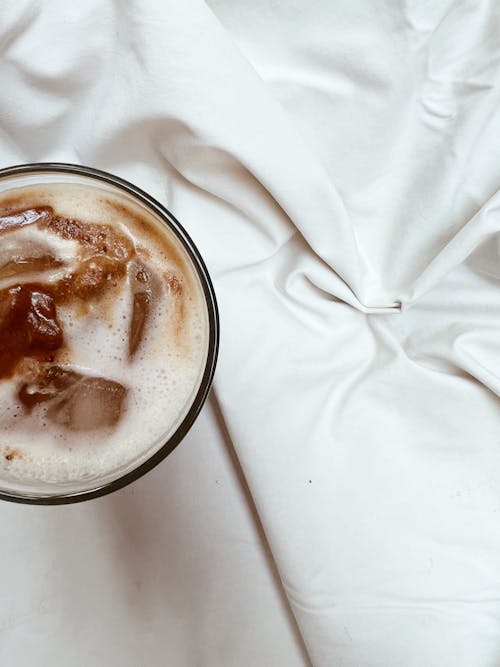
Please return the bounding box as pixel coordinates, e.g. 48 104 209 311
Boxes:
0 162 220 505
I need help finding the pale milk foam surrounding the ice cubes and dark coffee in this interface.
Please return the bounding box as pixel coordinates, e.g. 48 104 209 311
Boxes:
0 183 208 483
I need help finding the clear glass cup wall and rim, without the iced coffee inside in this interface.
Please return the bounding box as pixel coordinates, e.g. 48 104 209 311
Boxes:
0 163 219 505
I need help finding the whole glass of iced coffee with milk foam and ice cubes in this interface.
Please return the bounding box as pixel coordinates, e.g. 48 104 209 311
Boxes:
0 164 219 504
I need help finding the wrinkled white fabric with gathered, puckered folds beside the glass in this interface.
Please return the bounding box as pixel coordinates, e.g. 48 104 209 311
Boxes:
0 0 500 667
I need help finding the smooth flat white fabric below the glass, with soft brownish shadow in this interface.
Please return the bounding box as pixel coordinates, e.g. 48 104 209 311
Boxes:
0 402 309 667
